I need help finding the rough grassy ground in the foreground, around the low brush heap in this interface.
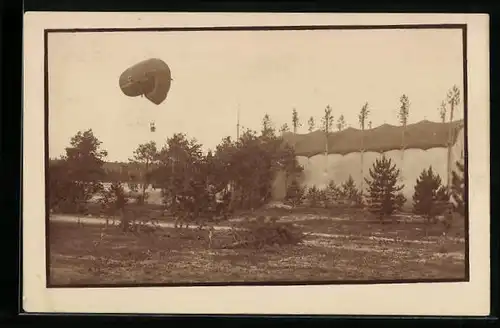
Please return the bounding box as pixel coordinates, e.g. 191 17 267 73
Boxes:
50 208 465 285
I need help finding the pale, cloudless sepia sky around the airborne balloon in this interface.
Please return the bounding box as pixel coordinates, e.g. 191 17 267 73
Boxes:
48 30 463 161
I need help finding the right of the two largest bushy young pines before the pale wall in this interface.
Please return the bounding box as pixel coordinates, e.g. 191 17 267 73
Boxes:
413 166 448 222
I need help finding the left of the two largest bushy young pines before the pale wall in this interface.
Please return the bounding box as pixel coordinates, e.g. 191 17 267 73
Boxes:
365 155 406 220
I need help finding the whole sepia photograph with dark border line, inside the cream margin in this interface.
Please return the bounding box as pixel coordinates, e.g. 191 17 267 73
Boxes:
25 12 487 316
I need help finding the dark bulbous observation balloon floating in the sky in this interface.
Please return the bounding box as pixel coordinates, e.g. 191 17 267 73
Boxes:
119 58 172 105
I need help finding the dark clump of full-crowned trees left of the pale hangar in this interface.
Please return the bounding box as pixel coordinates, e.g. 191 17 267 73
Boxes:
48 114 302 219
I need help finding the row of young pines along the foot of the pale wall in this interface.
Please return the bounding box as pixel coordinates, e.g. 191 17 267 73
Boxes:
285 155 465 227
